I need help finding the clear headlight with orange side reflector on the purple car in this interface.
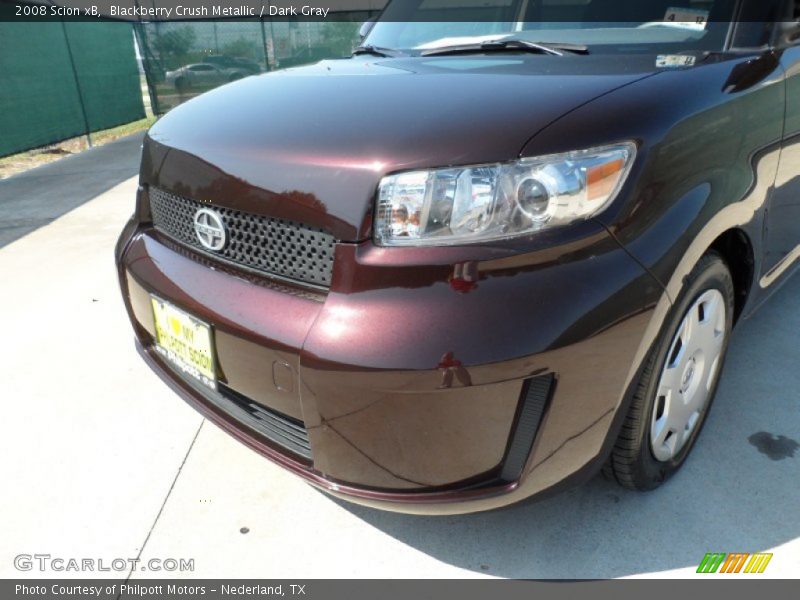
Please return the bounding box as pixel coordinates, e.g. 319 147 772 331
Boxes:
375 143 636 246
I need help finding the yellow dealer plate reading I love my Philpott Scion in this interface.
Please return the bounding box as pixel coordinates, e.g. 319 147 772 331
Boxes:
150 296 217 390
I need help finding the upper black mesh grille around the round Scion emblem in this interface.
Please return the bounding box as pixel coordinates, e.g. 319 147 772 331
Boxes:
150 188 334 287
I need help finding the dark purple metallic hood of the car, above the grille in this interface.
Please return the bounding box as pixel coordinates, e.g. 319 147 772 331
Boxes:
142 55 654 241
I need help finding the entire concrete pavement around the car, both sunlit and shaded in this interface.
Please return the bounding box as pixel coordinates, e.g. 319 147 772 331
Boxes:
0 143 800 578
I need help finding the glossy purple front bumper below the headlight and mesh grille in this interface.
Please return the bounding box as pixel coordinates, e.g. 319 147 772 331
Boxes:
117 203 661 513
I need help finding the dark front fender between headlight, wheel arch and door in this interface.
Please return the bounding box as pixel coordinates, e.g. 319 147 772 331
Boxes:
521 53 786 332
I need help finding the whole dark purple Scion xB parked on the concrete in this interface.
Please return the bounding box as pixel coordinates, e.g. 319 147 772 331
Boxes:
116 0 800 513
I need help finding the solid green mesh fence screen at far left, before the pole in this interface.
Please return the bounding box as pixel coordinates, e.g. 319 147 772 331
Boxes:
0 21 145 156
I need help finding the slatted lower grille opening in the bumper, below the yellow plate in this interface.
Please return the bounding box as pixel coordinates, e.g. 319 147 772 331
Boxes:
219 383 311 460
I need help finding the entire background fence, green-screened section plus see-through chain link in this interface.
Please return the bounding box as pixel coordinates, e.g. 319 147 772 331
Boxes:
0 4 380 157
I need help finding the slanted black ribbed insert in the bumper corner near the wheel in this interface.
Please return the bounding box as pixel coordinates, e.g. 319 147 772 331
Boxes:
500 373 555 482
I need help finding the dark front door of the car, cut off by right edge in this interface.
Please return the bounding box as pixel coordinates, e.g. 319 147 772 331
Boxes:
762 0 800 287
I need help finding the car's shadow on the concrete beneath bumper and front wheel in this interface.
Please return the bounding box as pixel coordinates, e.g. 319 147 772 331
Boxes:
336 276 800 578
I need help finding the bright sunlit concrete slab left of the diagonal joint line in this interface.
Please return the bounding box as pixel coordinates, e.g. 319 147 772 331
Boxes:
0 175 201 577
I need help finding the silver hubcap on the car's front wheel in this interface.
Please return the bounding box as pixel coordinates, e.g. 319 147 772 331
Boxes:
650 290 726 462
